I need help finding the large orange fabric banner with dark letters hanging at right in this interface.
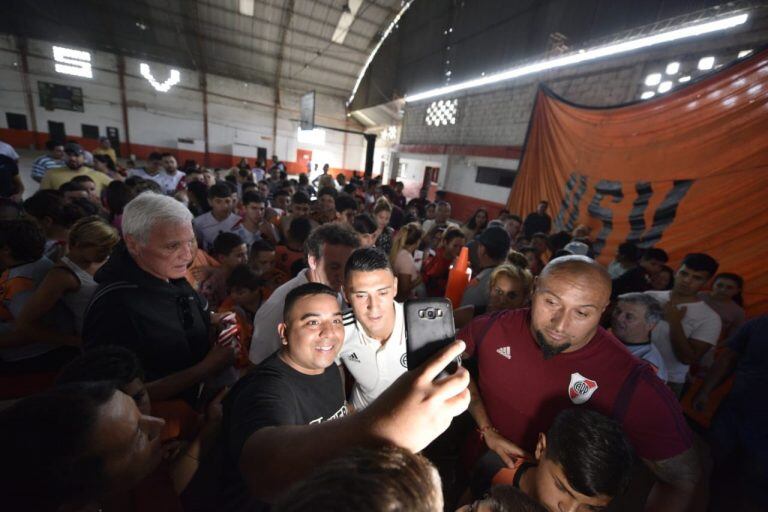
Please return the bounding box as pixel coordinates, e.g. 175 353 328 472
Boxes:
508 51 768 316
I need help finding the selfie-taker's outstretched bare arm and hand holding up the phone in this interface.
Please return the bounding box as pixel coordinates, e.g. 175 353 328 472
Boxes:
239 342 469 500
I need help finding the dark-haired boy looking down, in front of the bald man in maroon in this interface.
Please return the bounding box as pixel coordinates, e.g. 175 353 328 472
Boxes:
472 407 634 510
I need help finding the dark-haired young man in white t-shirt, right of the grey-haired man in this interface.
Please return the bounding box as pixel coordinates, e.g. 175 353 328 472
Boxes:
645 253 721 397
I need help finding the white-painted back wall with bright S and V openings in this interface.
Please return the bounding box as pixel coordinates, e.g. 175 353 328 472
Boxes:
0 35 365 170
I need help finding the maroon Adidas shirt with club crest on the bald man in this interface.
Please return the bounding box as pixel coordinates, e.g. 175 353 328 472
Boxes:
457 309 692 460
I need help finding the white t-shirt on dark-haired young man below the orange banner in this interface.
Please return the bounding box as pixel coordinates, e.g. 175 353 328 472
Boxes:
645 290 721 384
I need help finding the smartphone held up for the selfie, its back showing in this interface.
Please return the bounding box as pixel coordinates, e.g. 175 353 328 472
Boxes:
404 298 461 377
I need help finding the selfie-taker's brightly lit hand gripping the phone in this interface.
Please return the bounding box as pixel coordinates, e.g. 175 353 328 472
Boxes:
359 341 469 452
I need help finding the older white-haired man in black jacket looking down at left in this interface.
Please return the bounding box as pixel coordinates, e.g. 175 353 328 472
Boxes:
83 192 234 403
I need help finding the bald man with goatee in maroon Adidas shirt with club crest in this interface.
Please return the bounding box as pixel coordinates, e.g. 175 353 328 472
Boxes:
457 256 701 510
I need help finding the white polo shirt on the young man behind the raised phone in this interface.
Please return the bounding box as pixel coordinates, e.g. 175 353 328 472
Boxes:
336 302 408 410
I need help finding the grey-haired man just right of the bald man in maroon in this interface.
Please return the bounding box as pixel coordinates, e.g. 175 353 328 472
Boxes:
611 292 667 382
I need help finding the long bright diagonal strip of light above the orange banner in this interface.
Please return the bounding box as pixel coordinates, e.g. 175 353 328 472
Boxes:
405 14 749 102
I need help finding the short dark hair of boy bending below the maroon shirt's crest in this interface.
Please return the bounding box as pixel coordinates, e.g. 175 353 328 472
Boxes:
546 407 634 497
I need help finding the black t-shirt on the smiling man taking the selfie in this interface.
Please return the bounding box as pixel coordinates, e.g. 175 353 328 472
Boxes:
221 352 347 511
